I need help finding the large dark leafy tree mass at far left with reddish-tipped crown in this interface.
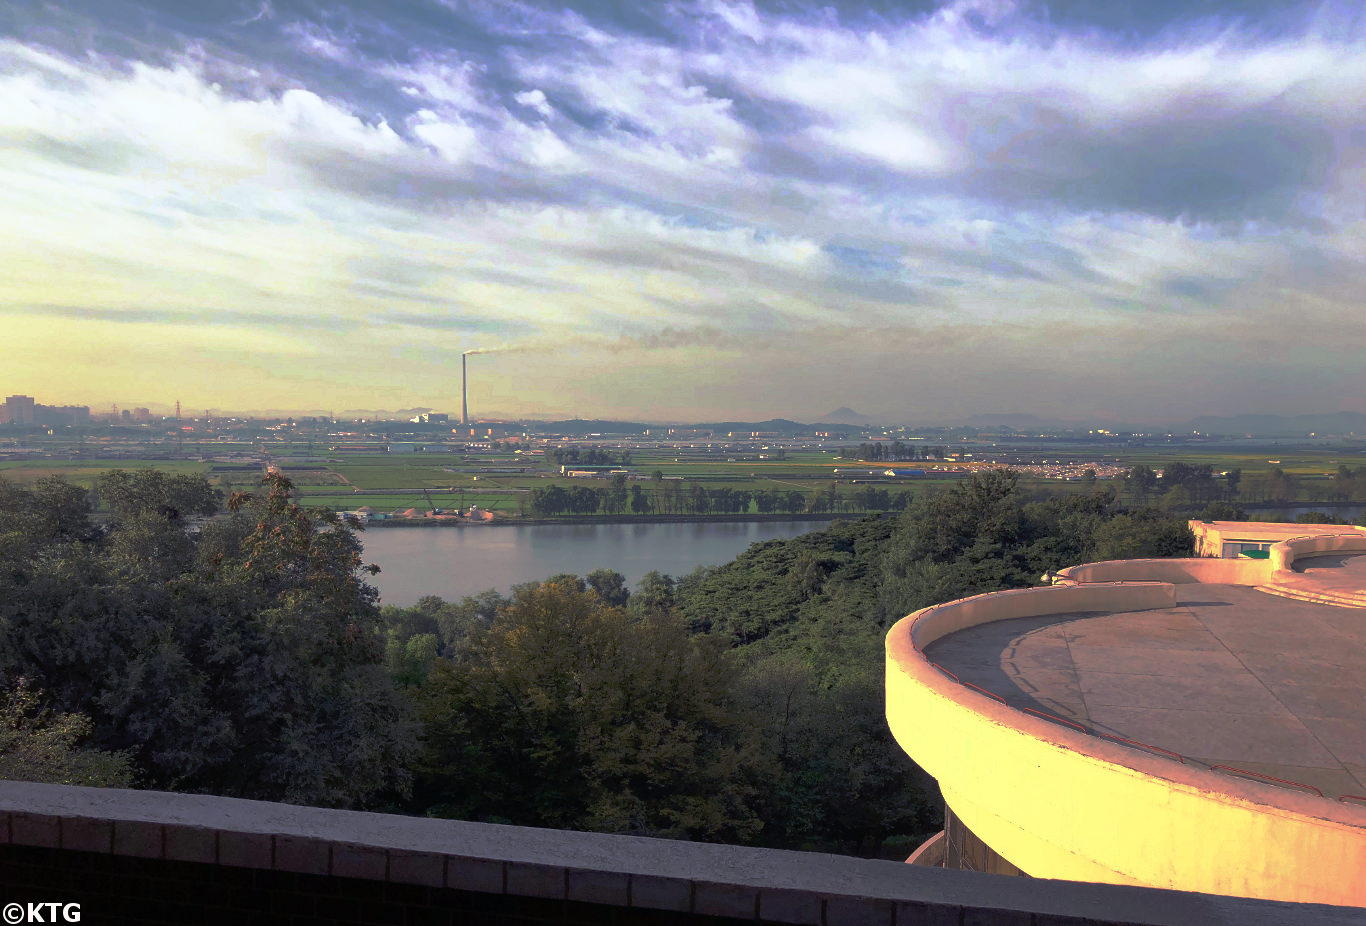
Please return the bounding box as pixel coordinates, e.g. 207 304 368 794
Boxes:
0 477 414 804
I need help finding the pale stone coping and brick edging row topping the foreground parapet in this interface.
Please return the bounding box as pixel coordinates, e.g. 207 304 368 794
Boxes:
0 781 1366 926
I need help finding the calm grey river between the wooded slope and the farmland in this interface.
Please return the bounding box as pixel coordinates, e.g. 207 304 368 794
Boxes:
361 520 826 606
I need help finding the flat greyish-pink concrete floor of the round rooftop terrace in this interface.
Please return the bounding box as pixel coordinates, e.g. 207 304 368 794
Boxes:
926 556 1366 798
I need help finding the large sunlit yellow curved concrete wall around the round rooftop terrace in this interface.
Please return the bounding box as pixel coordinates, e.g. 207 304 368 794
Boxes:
887 587 1366 906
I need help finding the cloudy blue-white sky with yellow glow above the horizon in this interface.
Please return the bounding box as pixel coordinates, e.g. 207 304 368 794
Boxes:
0 0 1366 423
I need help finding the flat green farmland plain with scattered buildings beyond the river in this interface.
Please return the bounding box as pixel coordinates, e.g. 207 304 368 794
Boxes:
0 426 1366 519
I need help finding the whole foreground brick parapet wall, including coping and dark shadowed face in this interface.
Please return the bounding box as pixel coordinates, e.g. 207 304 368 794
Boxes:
0 783 1366 926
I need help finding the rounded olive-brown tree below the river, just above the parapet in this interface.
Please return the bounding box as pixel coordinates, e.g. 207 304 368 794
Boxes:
417 580 764 840
